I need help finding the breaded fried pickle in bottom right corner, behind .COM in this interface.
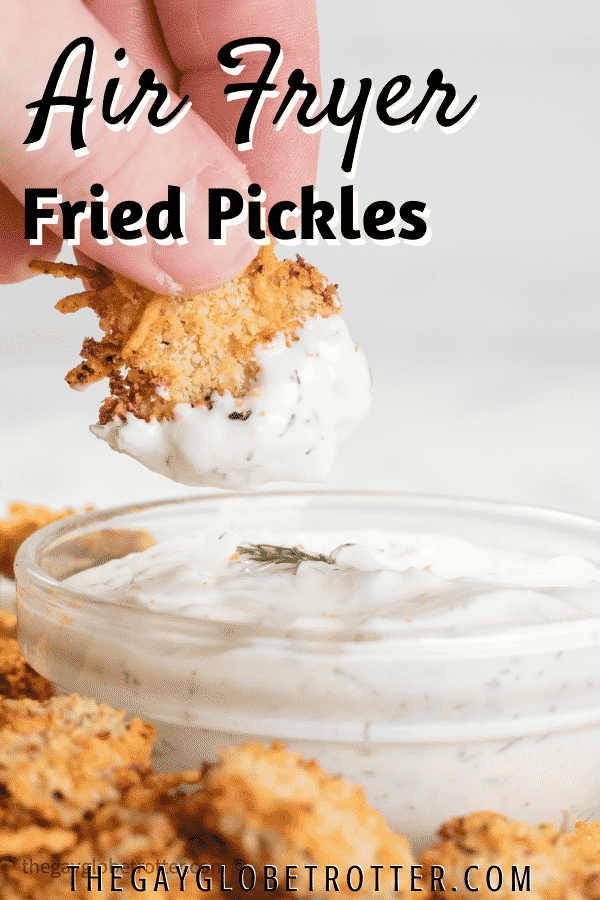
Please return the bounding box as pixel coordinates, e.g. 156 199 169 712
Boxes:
420 811 600 900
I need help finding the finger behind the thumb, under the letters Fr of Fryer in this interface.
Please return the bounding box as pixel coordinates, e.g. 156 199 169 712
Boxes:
151 0 320 206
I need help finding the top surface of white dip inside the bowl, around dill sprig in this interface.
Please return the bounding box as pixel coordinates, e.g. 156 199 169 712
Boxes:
66 526 600 635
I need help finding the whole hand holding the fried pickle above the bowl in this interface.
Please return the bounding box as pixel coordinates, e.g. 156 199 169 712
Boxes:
0 0 319 293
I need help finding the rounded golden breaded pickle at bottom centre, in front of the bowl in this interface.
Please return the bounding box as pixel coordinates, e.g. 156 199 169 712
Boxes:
194 743 414 898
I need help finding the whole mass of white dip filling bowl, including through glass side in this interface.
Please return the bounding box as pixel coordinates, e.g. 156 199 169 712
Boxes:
57 520 600 845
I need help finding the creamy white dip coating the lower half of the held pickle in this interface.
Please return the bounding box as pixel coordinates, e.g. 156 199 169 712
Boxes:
91 315 371 489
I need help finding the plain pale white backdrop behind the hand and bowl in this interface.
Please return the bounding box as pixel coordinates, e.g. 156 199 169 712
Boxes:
0 0 600 515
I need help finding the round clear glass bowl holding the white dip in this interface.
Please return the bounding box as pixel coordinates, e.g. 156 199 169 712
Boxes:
16 491 600 845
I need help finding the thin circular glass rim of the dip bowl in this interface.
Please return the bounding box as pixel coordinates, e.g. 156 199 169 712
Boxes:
14 489 600 659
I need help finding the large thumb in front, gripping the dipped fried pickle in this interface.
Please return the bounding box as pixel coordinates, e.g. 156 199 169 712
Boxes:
0 0 256 293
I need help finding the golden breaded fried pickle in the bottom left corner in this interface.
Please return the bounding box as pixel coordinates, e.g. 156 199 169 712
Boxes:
0 695 159 900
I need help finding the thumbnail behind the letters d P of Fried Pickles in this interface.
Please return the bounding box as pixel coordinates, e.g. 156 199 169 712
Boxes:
152 167 258 293
